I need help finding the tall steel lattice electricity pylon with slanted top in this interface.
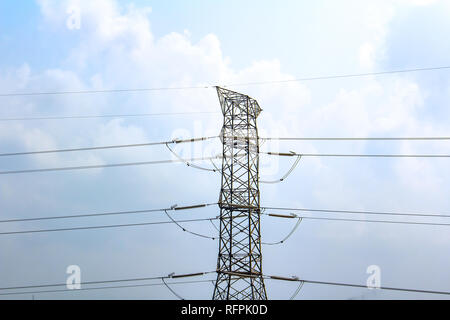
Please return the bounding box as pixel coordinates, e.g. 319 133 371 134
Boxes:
213 87 267 300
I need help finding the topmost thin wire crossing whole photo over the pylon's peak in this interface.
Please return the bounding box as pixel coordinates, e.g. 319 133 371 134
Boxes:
0 66 450 97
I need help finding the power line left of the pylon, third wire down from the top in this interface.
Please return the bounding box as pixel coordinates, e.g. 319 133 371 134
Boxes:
0 136 217 157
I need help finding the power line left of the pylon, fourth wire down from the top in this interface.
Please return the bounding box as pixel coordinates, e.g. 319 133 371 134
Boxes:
0 156 221 175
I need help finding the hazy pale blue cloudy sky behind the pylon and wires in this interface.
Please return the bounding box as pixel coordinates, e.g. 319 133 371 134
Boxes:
0 0 450 299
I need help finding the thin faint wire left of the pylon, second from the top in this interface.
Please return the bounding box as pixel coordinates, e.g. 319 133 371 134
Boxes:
0 111 219 121
